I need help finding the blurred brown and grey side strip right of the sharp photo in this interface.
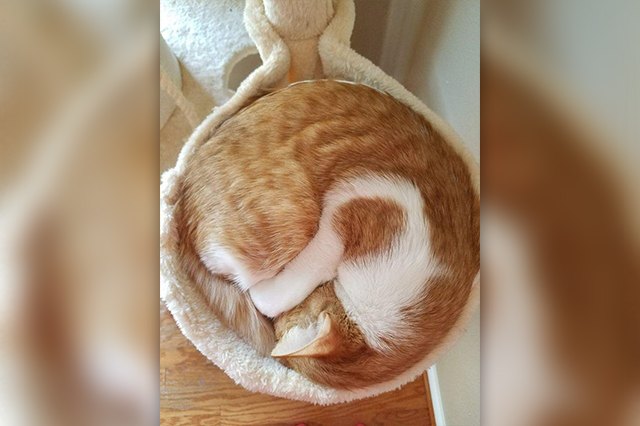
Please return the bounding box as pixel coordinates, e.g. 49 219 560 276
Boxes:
481 0 640 425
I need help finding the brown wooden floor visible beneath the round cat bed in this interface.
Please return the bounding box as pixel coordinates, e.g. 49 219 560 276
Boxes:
160 306 435 426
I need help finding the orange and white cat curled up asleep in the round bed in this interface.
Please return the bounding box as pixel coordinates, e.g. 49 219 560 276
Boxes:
176 80 480 389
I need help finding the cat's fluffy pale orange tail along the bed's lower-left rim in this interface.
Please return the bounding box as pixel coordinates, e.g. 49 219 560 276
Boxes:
172 200 275 355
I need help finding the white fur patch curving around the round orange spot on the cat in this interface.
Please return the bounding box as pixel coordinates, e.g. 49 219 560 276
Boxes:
331 176 445 350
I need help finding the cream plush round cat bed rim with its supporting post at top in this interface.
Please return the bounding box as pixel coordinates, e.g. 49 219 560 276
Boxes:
160 0 479 404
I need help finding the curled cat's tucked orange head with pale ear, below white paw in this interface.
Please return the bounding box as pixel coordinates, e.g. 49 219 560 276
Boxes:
271 282 366 363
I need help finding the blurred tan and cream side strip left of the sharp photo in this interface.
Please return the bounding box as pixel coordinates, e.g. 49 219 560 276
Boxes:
0 0 158 425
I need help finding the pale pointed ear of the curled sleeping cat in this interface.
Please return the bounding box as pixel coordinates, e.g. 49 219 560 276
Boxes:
271 312 340 358
